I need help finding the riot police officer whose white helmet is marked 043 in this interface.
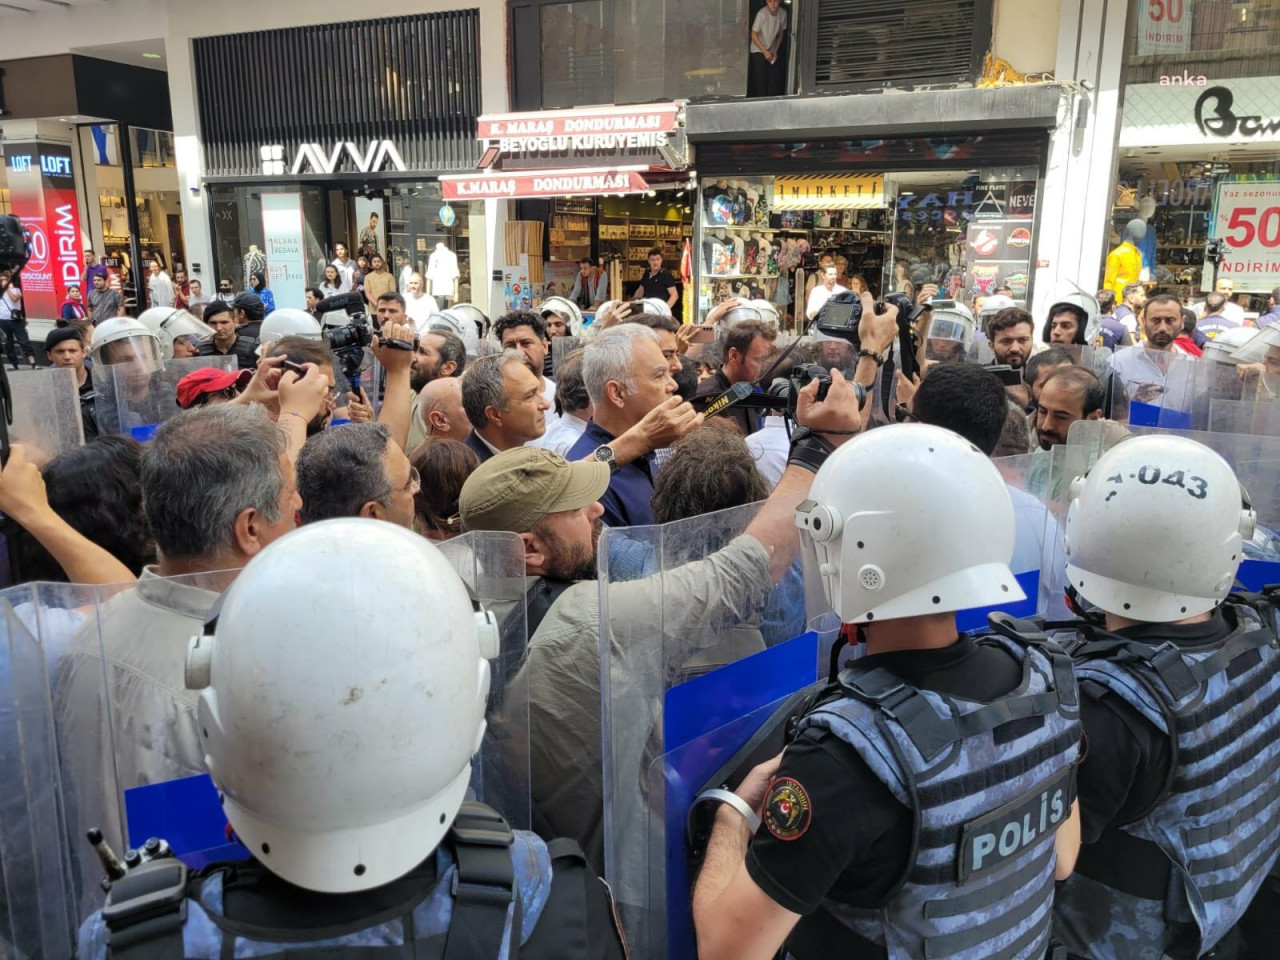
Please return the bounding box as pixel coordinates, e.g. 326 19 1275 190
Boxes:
1055 435 1280 960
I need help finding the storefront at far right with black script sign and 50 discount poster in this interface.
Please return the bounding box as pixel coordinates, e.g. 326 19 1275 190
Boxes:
1105 0 1280 312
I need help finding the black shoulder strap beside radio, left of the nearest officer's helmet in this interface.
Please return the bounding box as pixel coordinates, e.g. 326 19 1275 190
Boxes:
102 858 187 960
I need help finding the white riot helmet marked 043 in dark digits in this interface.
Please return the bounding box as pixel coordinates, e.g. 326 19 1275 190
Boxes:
1065 434 1256 623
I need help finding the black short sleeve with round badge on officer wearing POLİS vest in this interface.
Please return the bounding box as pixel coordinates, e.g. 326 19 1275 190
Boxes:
746 730 911 914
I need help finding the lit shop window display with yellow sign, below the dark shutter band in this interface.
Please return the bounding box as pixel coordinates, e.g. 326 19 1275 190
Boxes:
695 166 1039 328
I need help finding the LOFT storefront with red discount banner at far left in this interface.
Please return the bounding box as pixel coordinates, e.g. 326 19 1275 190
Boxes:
0 55 186 320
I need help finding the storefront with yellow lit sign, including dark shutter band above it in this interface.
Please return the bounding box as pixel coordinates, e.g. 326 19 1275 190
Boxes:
695 134 1047 323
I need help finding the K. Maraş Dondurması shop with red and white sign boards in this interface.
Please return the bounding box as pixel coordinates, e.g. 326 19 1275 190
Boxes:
442 102 695 316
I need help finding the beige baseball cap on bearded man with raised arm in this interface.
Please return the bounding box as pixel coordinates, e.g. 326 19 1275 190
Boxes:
458 447 609 534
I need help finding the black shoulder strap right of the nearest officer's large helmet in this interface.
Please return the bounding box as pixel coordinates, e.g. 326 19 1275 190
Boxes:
444 803 521 960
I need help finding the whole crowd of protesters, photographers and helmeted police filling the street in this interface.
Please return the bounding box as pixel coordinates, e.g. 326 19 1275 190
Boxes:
0 256 1280 960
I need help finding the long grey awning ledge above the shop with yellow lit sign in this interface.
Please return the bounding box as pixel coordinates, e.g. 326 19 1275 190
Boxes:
685 83 1068 143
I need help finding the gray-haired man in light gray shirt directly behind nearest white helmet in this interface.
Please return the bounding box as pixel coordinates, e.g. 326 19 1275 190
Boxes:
54 403 301 890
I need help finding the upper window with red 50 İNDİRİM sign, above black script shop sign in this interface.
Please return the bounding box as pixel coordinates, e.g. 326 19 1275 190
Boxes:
1125 0 1280 86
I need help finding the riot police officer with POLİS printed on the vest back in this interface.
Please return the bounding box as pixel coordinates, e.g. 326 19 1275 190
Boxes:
694 425 1080 960
